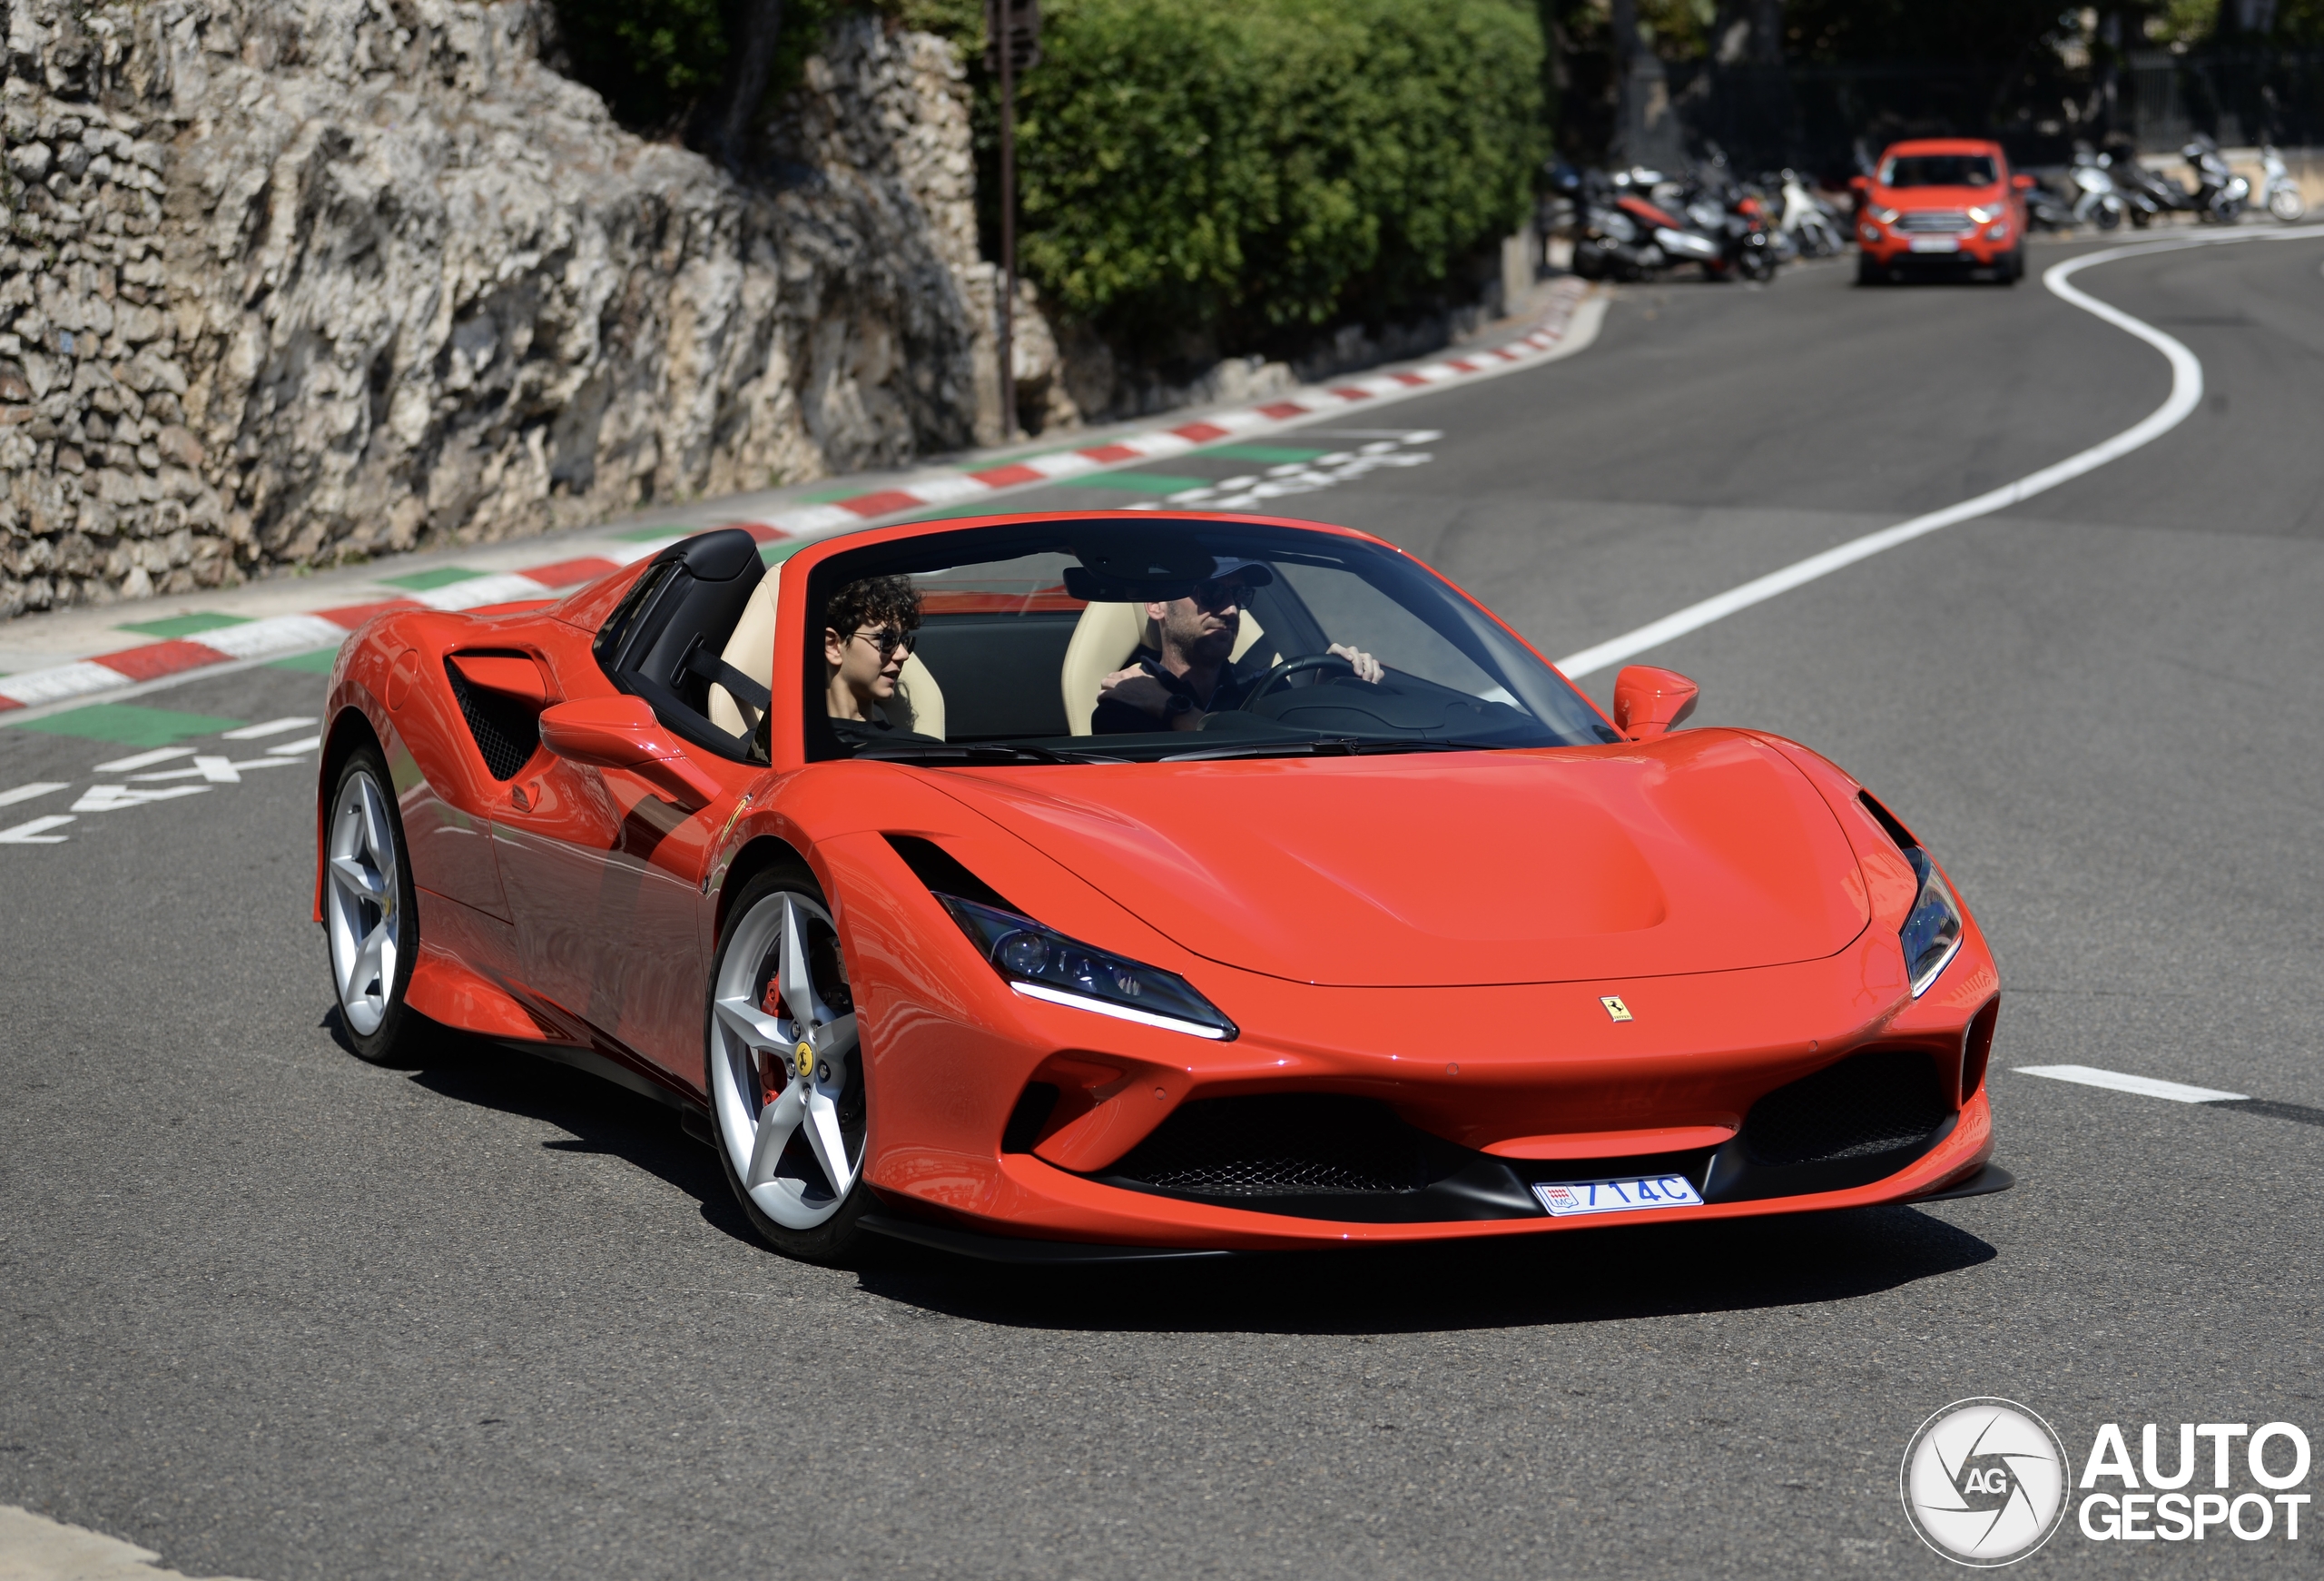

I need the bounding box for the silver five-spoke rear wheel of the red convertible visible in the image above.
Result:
[323,742,425,1065]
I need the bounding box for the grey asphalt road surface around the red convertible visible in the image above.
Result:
[0,242,2324,1581]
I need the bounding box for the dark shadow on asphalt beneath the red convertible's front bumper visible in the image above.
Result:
[860,1207,1999,1335]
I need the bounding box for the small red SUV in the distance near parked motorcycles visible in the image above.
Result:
[1850,137,2034,286]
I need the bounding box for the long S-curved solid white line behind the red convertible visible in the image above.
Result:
[1557,225,2324,679]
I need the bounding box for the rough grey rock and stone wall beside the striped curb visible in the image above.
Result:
[0,0,1036,614]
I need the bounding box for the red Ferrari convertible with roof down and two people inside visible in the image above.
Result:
[316,511,2008,1260]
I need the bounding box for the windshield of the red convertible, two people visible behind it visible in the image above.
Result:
[806,521,1620,763]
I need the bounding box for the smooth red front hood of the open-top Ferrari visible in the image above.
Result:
[932,730,1871,988]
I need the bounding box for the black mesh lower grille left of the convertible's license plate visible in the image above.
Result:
[1107,1095,1427,1198]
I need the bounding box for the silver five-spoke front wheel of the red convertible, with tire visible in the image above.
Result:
[704,863,874,1262]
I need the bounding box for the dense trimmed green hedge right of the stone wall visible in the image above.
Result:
[1018,0,1545,346]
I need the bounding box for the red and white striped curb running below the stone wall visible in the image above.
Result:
[0,279,1590,714]
